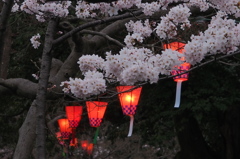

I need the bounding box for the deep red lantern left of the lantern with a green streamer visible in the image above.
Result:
[65,106,83,128]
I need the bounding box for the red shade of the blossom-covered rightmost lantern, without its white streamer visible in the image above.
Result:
[163,42,191,82]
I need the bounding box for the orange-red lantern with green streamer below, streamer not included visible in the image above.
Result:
[86,101,108,127]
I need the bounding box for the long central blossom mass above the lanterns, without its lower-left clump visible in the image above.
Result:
[75,47,183,88]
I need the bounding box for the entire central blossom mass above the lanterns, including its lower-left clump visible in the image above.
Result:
[61,48,184,98]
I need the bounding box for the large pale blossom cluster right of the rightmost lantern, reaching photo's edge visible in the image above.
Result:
[185,12,240,65]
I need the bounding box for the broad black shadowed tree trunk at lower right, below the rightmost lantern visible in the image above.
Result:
[174,111,216,159]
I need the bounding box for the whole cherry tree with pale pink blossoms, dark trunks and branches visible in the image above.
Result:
[0,0,240,159]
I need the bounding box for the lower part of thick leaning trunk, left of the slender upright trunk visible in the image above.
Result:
[13,100,36,159]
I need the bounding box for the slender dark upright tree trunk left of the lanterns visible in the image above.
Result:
[36,19,57,159]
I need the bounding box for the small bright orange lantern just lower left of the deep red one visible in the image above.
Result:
[58,119,72,139]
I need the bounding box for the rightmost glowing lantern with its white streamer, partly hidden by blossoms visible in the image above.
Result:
[163,42,191,108]
